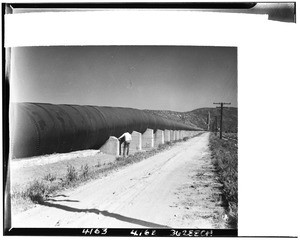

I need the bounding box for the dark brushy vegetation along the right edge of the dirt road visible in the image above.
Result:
[209,134,238,228]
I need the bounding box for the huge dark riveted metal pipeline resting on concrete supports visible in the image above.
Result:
[10,103,199,158]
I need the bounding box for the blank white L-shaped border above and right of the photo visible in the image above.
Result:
[5,3,300,236]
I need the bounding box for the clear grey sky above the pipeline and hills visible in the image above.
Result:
[11,46,237,112]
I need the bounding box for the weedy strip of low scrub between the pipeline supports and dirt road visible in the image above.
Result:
[11,133,202,213]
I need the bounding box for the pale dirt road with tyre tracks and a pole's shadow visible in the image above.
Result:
[12,133,225,228]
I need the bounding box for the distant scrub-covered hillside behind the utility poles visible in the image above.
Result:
[145,107,238,132]
